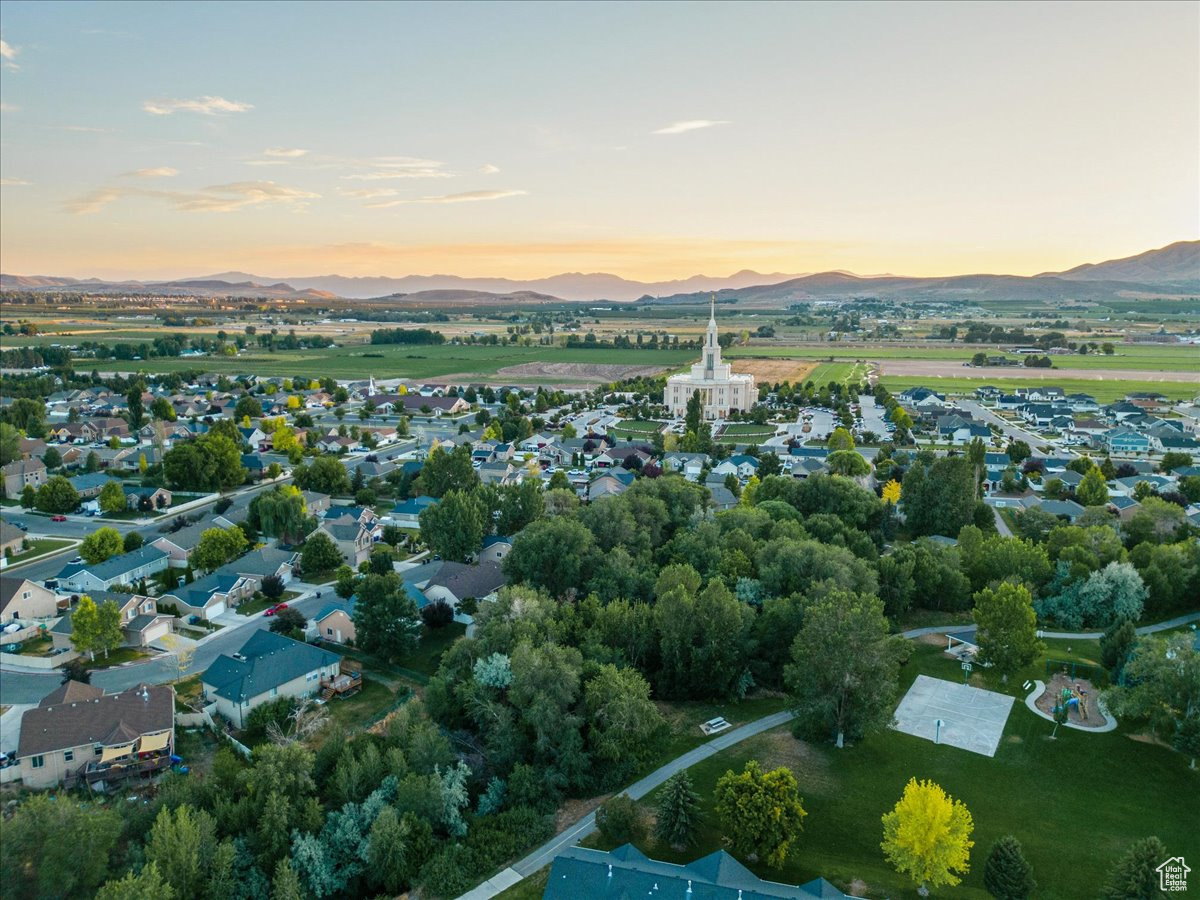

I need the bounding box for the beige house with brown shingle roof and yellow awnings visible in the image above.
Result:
[17,682,175,790]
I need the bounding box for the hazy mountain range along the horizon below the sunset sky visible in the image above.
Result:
[0,241,1200,307]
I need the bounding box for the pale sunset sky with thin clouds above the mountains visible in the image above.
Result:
[0,0,1200,280]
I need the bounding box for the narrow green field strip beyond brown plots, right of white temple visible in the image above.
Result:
[724,343,1200,372]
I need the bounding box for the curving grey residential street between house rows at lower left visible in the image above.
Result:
[0,583,334,706]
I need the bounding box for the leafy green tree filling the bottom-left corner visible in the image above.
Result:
[0,793,121,899]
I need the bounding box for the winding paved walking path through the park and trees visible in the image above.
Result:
[458,612,1200,900]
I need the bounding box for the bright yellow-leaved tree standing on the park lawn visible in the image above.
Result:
[880,778,974,896]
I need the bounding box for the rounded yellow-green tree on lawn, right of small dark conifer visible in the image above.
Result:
[713,760,808,869]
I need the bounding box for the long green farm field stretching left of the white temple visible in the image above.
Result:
[87,344,696,383]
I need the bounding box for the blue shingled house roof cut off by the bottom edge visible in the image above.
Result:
[542,844,848,900]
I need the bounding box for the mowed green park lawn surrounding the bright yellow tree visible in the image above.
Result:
[595,642,1200,898]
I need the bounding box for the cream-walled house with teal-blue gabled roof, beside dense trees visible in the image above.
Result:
[200,631,342,728]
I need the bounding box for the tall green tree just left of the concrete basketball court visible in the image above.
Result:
[784,590,901,748]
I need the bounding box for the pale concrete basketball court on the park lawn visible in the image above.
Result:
[892,676,1013,756]
